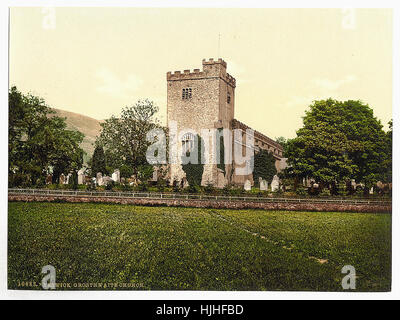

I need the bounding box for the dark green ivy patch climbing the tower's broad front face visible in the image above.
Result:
[182,135,204,186]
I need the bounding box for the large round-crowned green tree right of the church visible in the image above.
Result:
[286,99,387,188]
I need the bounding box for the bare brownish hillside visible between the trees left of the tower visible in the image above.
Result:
[53,108,103,162]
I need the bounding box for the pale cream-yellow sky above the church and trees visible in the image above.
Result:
[9,7,392,138]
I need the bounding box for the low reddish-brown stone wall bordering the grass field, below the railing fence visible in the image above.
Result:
[8,195,392,213]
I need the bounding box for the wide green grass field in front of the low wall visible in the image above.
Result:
[8,202,391,291]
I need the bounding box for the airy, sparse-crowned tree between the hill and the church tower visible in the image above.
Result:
[96,99,160,174]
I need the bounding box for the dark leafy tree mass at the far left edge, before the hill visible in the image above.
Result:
[8,86,84,186]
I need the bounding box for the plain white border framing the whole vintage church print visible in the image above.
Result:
[0,0,400,300]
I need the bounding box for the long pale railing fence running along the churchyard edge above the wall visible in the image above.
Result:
[8,189,392,205]
